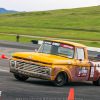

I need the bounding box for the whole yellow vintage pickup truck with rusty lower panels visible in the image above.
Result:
[9,40,100,86]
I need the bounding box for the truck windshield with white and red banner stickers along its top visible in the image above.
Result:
[38,41,75,58]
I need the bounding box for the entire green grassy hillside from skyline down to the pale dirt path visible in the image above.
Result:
[0,6,100,41]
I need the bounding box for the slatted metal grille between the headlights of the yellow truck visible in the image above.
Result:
[16,61,46,74]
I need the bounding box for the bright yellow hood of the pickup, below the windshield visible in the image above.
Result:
[13,52,72,64]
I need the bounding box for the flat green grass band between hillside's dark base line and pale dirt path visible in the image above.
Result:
[0,27,100,41]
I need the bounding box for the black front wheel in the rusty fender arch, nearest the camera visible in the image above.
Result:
[54,72,67,87]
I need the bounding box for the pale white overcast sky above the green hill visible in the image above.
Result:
[0,0,100,12]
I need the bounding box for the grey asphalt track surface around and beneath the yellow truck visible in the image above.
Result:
[0,40,100,100]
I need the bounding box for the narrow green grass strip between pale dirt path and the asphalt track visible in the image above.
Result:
[0,34,100,48]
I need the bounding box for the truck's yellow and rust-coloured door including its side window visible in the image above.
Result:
[74,47,89,81]
